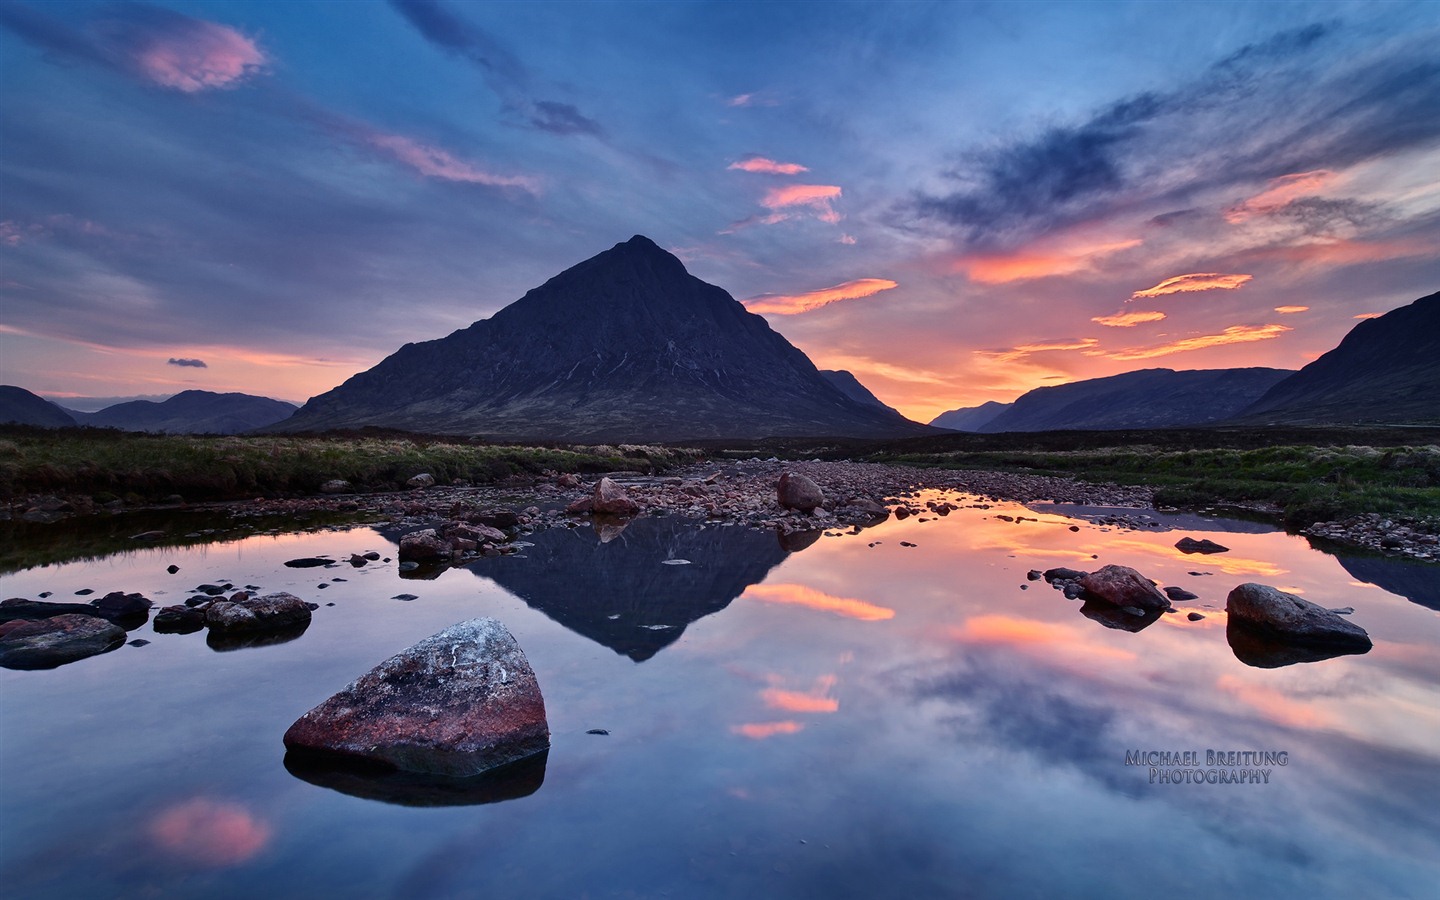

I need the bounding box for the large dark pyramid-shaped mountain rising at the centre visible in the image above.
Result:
[279,236,929,442]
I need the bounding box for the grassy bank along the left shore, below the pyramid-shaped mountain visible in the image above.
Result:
[0,428,693,503]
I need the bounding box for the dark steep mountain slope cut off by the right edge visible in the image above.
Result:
[1240,292,1440,425]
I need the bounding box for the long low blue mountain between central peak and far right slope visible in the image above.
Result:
[979,369,1293,433]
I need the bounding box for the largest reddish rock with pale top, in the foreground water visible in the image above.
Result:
[285,618,550,776]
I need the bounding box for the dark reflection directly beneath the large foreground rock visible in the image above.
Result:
[285,750,549,806]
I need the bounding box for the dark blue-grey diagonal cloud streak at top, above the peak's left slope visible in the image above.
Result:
[390,0,605,138]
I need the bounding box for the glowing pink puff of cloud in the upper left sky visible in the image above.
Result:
[122,14,269,94]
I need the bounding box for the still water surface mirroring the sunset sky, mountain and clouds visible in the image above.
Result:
[0,495,1440,900]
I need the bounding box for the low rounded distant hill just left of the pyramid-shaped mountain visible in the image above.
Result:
[73,390,295,435]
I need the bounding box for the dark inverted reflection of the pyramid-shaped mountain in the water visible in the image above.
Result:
[467,517,789,662]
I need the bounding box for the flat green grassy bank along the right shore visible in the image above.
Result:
[870,445,1440,527]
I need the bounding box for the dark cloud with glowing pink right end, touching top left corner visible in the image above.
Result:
[0,3,269,94]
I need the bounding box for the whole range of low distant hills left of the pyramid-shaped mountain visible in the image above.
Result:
[0,384,297,435]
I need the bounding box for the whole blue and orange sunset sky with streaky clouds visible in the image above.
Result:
[0,0,1440,420]
